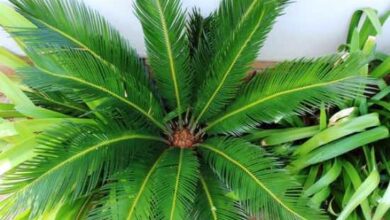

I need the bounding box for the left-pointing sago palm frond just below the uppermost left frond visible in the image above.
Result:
[19,50,165,130]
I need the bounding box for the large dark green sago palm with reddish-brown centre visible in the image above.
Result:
[0,0,372,220]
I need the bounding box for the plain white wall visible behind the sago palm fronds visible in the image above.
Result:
[0,0,390,60]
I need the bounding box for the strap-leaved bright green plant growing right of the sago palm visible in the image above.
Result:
[248,8,390,220]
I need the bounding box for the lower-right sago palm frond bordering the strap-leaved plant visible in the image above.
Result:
[199,138,325,219]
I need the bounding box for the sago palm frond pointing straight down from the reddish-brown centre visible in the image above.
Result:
[155,148,199,220]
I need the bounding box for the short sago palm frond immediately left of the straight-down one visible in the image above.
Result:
[89,151,165,220]
